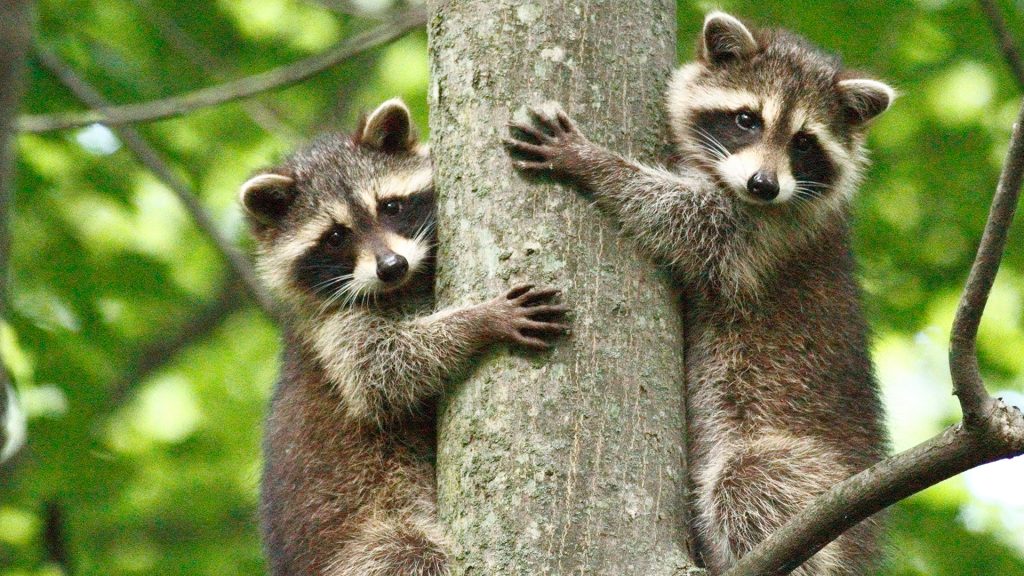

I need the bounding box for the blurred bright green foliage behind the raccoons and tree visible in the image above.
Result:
[0,0,1024,576]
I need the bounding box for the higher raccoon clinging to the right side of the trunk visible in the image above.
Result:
[507,12,895,576]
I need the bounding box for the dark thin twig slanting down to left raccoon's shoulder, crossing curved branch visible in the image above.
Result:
[36,48,275,318]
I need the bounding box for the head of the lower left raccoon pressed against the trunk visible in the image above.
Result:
[240,99,435,310]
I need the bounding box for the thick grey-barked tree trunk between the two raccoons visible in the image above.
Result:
[429,0,690,576]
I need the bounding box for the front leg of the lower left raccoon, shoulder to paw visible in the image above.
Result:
[312,286,568,423]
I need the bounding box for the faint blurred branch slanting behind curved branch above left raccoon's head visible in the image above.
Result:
[136,0,301,142]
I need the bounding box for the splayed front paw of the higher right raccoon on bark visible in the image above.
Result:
[503,104,590,176]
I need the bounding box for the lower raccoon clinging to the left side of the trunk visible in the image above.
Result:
[241,100,566,576]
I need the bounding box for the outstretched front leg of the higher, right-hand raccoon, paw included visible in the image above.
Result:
[505,107,734,271]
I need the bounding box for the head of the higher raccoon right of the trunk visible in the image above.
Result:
[668,12,896,205]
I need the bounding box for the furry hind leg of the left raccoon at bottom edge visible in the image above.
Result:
[325,517,449,576]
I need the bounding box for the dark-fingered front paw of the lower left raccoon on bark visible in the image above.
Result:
[483,285,569,349]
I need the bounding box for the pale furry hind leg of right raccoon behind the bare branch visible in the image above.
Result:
[695,435,877,576]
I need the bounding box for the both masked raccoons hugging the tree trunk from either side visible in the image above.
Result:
[242,8,895,576]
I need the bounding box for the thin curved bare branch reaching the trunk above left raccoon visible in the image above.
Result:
[18,7,427,132]
